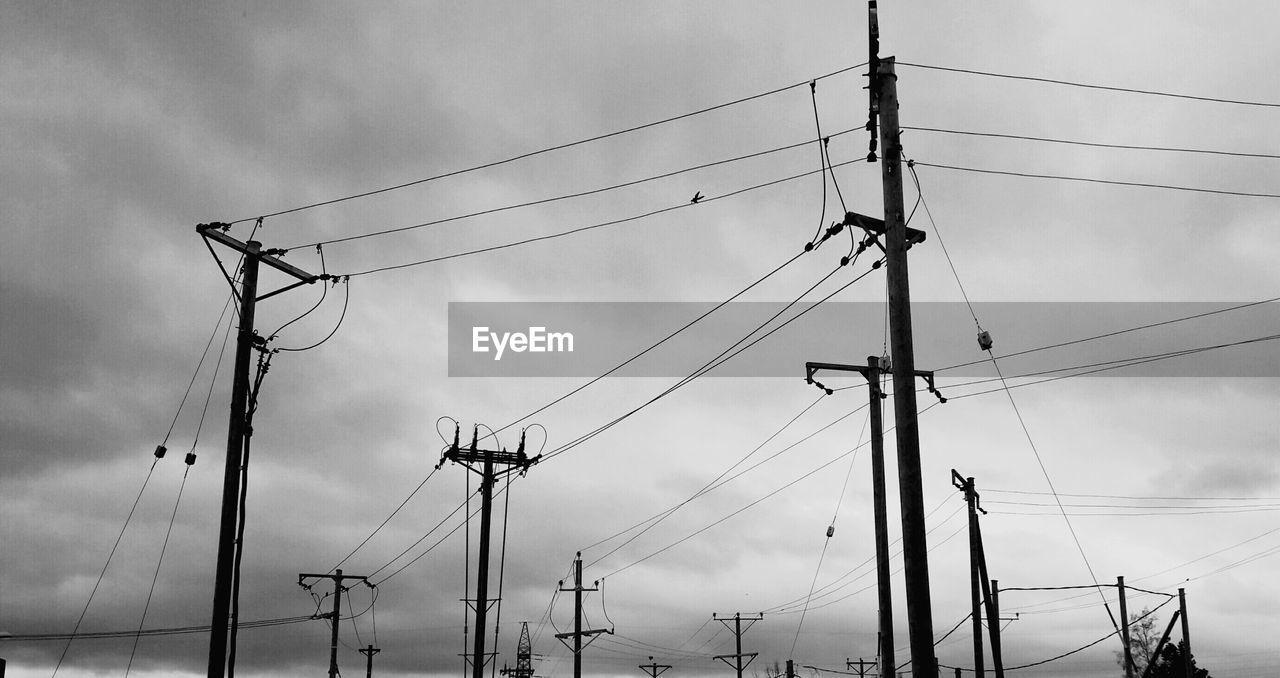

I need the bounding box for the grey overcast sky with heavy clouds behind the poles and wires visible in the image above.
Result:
[0,1,1280,678]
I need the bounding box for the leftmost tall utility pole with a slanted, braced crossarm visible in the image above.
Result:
[196,223,321,678]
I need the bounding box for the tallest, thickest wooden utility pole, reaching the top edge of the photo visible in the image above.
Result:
[868,0,937,660]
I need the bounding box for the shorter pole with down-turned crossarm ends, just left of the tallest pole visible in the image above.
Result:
[804,358,946,675]
